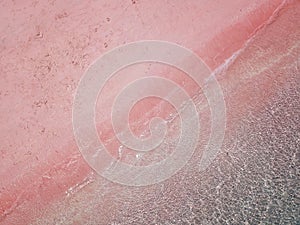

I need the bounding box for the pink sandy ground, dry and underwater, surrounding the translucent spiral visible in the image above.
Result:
[0,0,300,224]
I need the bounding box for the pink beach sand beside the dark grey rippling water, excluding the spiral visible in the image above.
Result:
[0,0,300,224]
